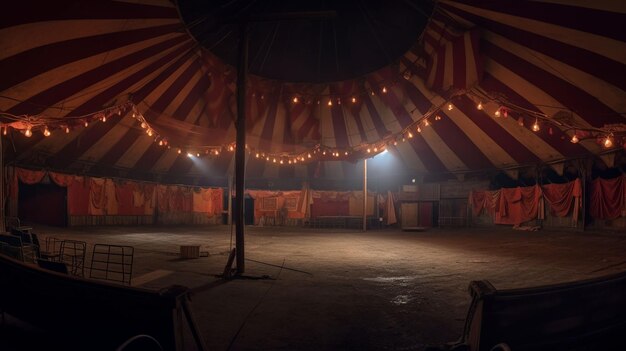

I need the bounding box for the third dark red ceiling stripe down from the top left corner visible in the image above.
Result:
[9,37,183,115]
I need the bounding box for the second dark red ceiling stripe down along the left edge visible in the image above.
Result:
[0,25,178,91]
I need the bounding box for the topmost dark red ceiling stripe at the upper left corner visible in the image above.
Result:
[0,0,178,30]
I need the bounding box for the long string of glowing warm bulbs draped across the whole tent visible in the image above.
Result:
[0,85,626,165]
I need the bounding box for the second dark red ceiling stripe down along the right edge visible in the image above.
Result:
[439,3,626,90]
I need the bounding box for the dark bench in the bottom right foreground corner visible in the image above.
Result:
[431,272,626,351]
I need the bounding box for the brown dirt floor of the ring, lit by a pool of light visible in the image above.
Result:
[1,226,626,350]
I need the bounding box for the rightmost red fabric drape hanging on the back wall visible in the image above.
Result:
[589,176,626,219]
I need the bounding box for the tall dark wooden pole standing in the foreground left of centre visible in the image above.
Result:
[235,20,248,275]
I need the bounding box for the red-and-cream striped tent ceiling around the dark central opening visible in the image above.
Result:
[0,0,626,186]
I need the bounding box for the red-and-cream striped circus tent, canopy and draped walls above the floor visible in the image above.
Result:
[0,0,626,348]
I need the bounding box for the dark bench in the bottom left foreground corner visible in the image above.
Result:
[0,255,205,350]
